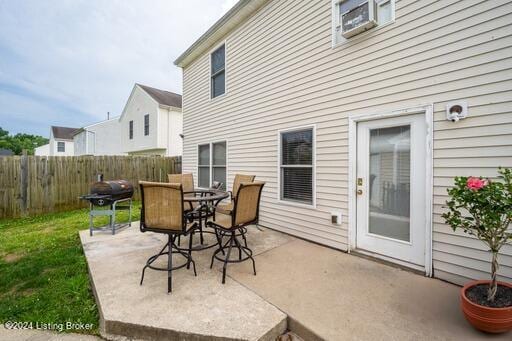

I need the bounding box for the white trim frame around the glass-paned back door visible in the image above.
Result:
[347,104,433,277]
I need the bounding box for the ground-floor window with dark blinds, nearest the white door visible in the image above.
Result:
[279,127,315,205]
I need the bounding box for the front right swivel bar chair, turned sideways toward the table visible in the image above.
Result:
[207,181,265,284]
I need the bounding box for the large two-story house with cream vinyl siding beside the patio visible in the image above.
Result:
[175,0,512,284]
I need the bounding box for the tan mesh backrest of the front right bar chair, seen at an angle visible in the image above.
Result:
[233,181,265,226]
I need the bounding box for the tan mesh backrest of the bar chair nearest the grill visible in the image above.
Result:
[139,181,185,231]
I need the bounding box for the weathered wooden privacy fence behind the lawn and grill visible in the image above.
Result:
[0,155,181,218]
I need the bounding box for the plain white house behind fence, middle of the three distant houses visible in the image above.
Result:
[73,117,126,156]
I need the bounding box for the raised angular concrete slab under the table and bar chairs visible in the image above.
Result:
[80,223,293,340]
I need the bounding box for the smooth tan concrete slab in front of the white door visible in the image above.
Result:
[230,240,512,341]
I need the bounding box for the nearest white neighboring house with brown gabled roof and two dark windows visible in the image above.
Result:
[119,84,183,156]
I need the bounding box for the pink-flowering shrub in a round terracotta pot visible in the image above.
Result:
[442,168,512,333]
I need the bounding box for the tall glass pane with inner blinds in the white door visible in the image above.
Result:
[368,125,411,241]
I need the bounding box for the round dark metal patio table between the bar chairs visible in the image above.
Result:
[183,189,229,251]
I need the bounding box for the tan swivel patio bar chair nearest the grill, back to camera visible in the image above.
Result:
[139,181,197,293]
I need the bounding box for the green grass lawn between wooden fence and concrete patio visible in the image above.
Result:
[0,203,140,334]
